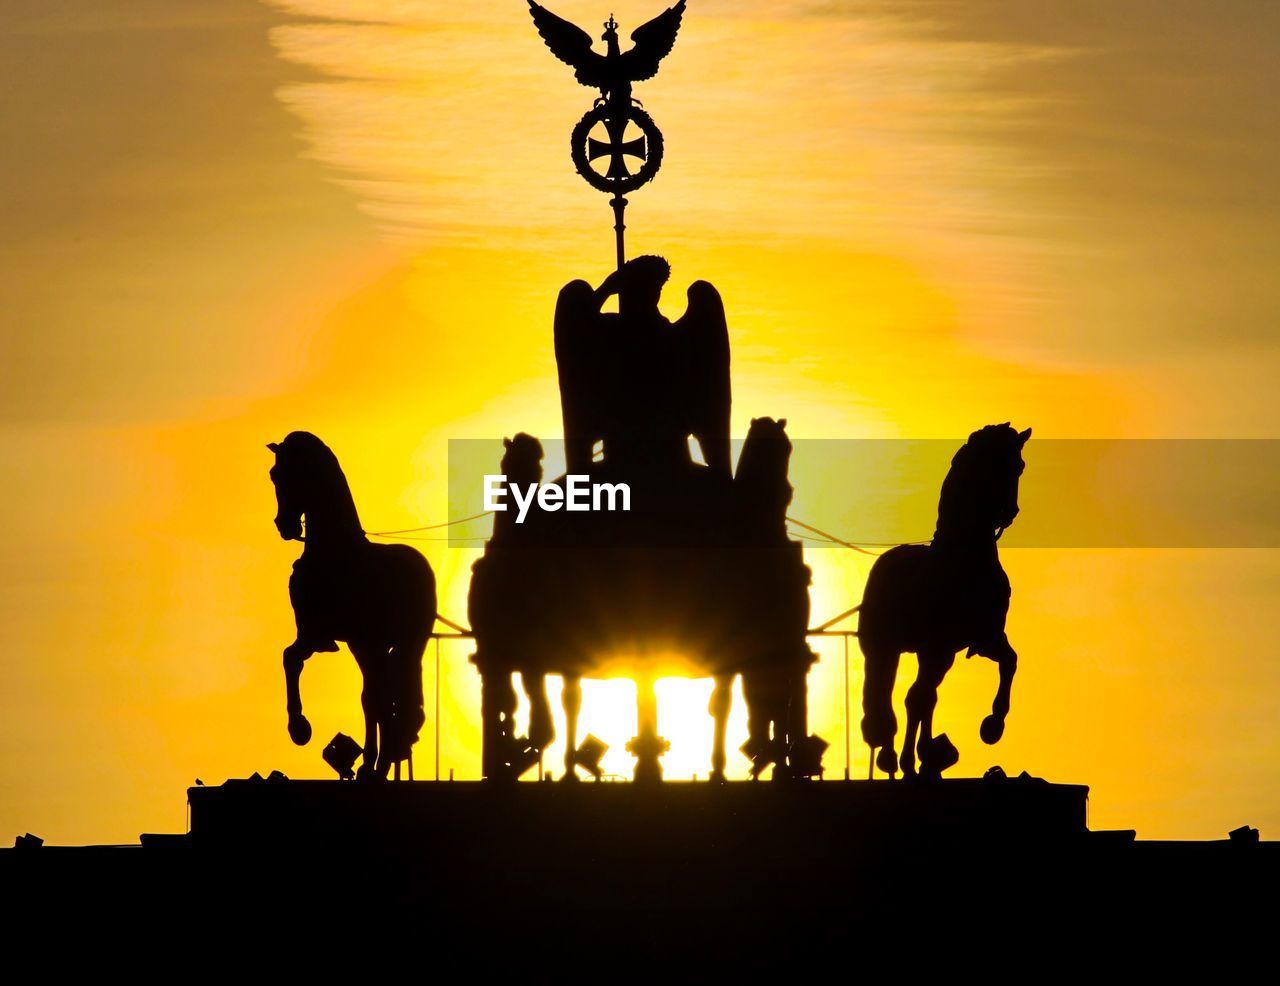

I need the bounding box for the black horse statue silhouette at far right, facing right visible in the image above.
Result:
[858,423,1032,777]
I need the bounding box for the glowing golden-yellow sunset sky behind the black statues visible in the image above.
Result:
[0,0,1280,843]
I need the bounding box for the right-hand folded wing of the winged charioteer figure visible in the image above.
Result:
[676,280,732,479]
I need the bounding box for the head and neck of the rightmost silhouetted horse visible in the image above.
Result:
[938,421,1032,539]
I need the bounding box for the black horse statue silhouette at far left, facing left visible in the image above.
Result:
[268,432,436,779]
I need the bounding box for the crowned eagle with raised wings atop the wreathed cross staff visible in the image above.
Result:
[529,0,685,105]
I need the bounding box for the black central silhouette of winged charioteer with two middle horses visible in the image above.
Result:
[468,256,820,780]
